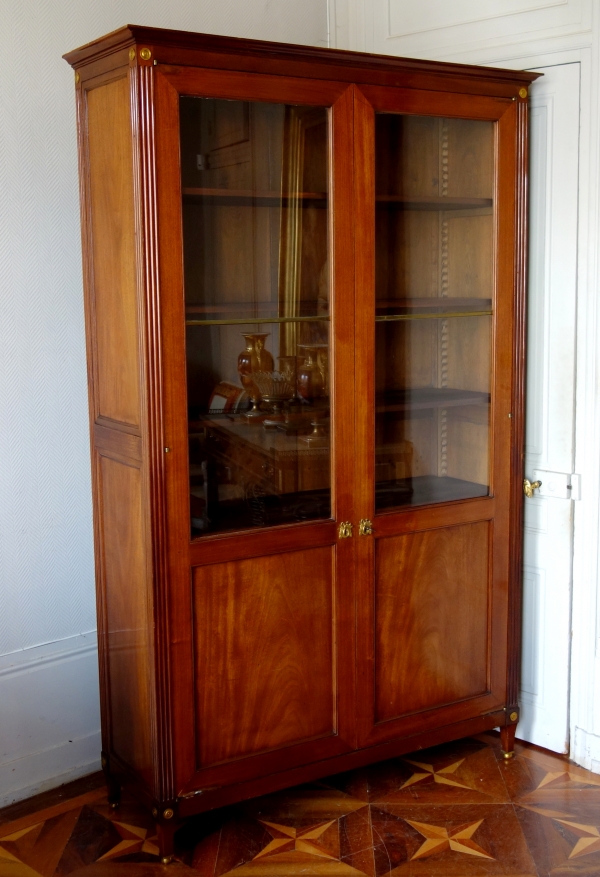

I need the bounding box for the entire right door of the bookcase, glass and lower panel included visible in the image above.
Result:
[355,88,520,745]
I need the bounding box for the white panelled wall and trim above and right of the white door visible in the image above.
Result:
[330,0,600,772]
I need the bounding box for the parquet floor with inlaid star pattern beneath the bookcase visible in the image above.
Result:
[0,734,600,877]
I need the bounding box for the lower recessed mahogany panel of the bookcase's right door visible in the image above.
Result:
[375,521,490,722]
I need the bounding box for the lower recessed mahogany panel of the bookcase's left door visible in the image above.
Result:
[193,547,337,768]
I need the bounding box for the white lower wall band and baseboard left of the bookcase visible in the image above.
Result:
[0,631,101,807]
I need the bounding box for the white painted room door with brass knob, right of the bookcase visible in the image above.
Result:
[517,64,579,752]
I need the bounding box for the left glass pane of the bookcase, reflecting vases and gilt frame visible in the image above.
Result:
[180,97,331,537]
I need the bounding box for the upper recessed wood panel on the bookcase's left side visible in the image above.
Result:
[87,78,140,426]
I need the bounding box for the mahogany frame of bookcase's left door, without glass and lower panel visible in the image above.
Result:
[154,65,355,797]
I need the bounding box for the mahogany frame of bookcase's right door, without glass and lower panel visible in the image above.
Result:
[355,86,527,746]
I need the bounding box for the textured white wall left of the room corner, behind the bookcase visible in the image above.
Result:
[0,0,328,806]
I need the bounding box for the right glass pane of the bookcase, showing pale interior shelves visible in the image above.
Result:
[375,114,494,510]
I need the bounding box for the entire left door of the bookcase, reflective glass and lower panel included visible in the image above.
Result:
[155,67,355,796]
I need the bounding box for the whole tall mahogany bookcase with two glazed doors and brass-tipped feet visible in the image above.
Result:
[65,25,538,861]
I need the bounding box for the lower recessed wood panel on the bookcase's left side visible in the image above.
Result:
[98,456,154,788]
